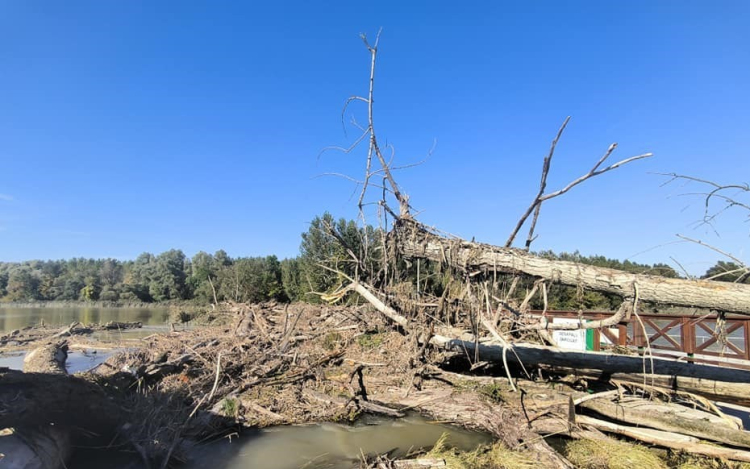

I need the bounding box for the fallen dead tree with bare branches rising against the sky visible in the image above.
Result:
[328,34,750,402]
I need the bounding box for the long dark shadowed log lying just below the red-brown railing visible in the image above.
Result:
[430,335,750,383]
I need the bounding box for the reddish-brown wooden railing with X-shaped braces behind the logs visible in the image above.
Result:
[531,311,750,369]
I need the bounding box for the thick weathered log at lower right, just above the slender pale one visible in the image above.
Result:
[576,399,750,448]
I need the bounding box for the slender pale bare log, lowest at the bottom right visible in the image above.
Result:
[576,415,750,462]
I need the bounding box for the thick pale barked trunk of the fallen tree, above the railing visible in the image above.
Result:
[400,219,750,315]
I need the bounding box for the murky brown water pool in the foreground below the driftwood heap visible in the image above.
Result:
[68,414,492,469]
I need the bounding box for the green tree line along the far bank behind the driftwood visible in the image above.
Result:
[0,212,750,310]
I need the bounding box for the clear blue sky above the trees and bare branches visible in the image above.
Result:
[0,1,750,273]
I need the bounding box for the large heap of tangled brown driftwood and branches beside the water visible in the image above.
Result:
[0,303,741,469]
